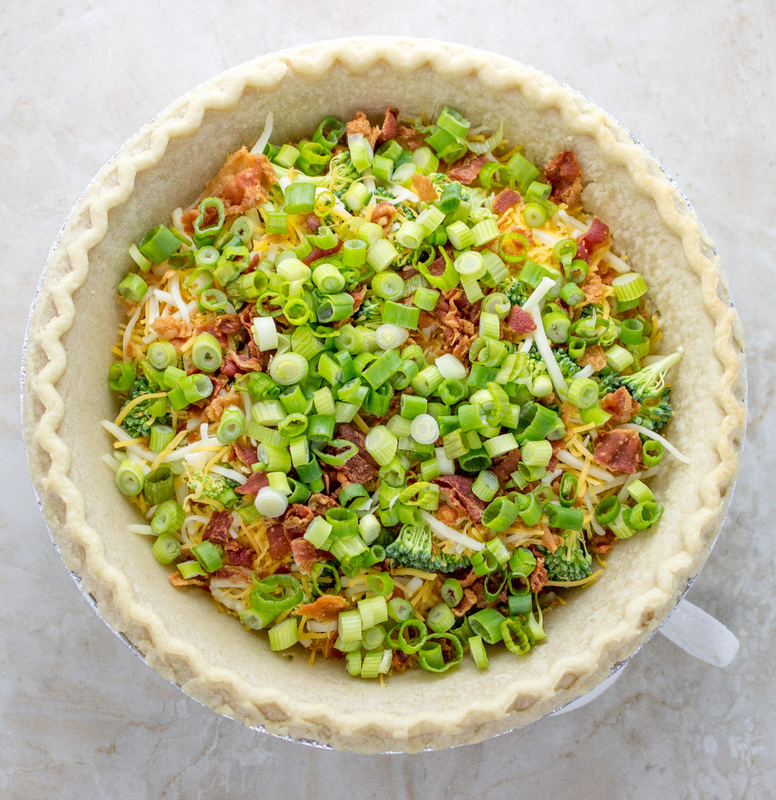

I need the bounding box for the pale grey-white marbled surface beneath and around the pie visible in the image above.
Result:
[0,0,776,800]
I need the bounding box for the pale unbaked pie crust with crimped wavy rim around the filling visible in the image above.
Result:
[24,38,745,752]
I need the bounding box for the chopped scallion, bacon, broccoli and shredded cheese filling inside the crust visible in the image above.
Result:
[103,107,686,678]
